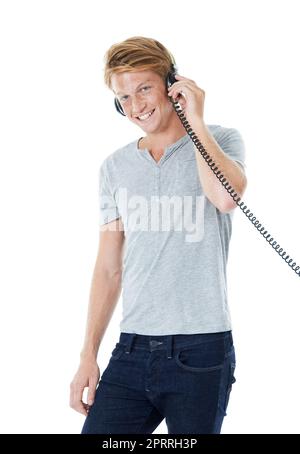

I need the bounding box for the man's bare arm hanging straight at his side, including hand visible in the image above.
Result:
[70,218,124,415]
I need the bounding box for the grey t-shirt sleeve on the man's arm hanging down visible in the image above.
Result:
[98,160,120,226]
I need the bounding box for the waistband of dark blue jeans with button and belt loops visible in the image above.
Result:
[119,331,233,358]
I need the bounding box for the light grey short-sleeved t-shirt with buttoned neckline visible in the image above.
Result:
[99,125,245,335]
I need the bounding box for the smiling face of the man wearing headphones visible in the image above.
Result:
[111,70,175,133]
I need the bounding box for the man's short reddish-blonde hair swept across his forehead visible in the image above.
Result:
[104,36,176,89]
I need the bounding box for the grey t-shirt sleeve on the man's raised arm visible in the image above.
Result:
[218,128,246,170]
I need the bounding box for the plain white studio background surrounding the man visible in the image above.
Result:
[0,0,300,434]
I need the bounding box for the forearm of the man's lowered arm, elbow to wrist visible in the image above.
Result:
[80,268,122,359]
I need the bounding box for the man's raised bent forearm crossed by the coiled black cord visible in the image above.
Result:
[194,121,247,211]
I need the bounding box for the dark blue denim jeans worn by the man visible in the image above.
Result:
[81,331,235,434]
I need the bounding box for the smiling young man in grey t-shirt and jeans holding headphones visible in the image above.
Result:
[70,36,247,434]
